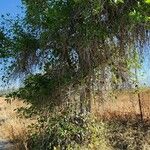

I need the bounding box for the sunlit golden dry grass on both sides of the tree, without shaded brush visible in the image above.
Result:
[0,89,150,150]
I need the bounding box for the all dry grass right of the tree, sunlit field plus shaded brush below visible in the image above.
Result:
[90,89,150,150]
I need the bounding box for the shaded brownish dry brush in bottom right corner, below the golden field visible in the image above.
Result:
[105,115,150,150]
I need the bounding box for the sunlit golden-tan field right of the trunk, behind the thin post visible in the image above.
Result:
[93,89,150,119]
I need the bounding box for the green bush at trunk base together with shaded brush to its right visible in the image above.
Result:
[25,109,150,150]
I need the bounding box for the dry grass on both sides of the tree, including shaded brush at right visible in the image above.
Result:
[0,89,150,150]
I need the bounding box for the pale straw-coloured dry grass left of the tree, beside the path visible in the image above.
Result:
[0,98,33,150]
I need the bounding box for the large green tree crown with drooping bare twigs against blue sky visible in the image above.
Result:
[1,0,150,111]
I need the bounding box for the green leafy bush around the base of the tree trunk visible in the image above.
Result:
[28,113,108,150]
